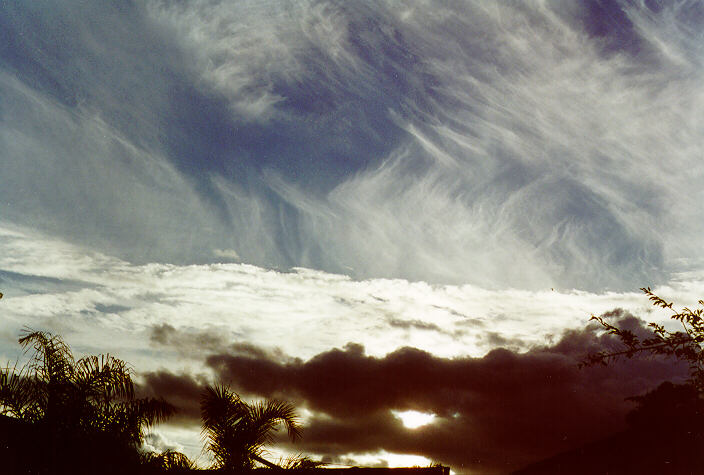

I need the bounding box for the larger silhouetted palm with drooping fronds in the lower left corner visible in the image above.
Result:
[0,330,175,474]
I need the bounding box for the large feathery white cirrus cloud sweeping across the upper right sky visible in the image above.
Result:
[278,0,701,288]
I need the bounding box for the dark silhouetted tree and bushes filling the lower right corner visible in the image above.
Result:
[568,287,704,473]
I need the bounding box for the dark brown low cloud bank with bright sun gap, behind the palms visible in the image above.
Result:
[146,310,686,473]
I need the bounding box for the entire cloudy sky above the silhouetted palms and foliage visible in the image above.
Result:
[0,0,704,474]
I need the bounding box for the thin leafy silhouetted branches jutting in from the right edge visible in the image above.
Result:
[582,287,704,394]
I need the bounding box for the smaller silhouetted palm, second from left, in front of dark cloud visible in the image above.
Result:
[200,385,301,470]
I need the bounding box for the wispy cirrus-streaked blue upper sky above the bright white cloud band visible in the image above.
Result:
[5,0,704,291]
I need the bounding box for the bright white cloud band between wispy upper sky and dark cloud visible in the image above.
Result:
[0,227,704,371]
